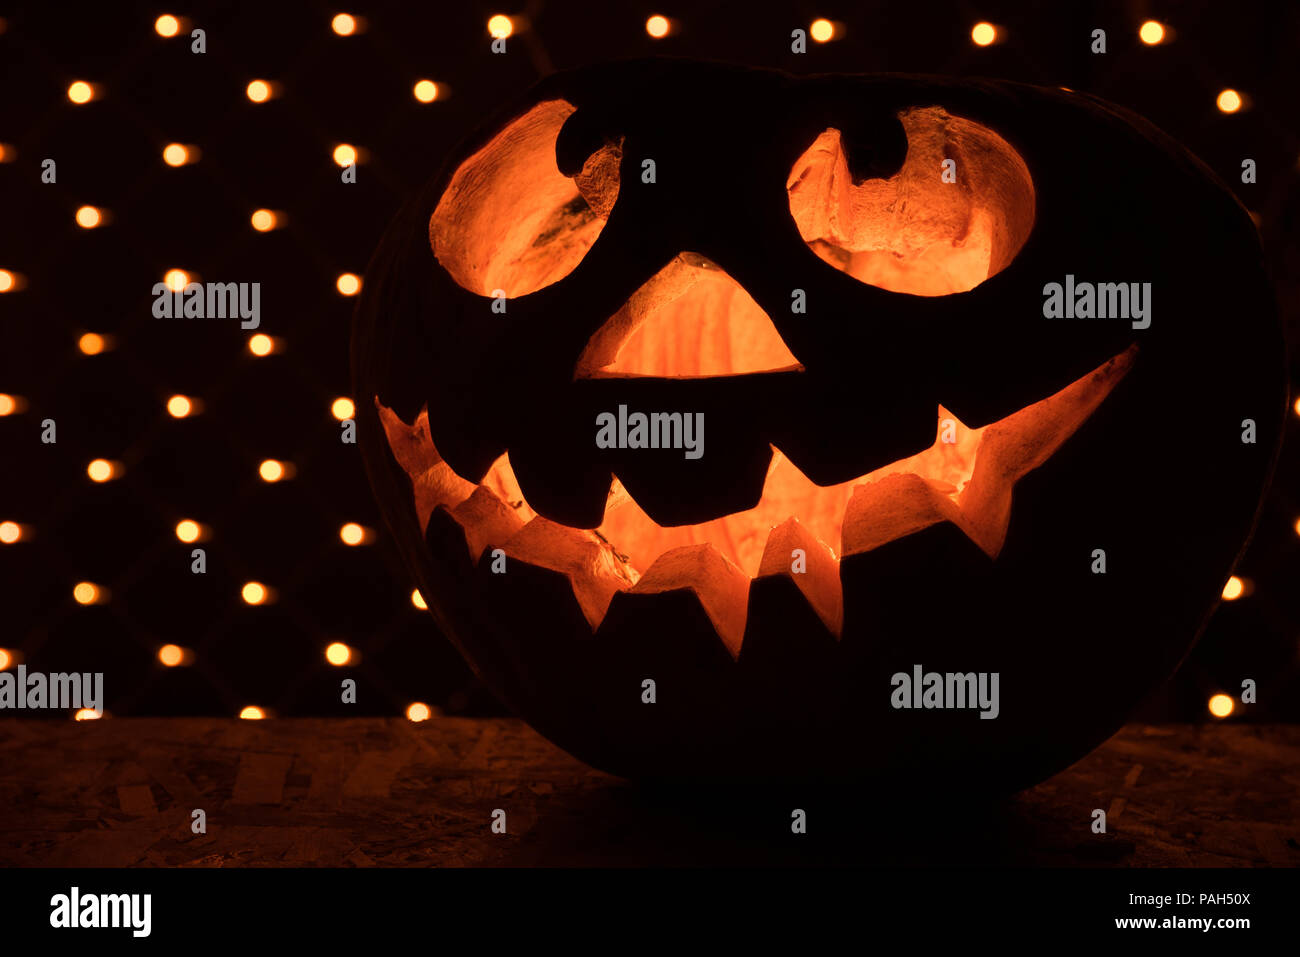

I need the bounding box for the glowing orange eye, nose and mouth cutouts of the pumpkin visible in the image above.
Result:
[410,100,1136,654]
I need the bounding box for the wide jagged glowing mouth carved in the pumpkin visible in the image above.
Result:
[374,346,1138,655]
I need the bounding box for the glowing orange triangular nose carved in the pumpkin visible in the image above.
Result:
[573,251,803,378]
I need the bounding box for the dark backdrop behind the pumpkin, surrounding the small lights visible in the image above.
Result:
[0,0,1300,720]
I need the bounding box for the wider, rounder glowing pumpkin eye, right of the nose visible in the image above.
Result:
[785,107,1034,295]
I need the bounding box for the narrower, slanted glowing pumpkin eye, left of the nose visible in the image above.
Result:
[429,100,623,299]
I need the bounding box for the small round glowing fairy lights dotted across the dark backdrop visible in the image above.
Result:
[0,13,1279,722]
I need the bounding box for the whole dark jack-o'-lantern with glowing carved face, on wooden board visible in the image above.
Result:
[352,61,1284,789]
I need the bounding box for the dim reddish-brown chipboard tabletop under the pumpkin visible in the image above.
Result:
[0,718,1300,867]
